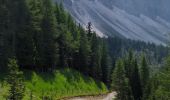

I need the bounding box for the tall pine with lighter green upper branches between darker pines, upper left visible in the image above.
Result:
[28,0,44,69]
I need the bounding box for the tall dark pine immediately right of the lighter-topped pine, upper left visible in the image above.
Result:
[41,0,58,69]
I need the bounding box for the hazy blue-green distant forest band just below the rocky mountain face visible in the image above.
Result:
[105,37,169,66]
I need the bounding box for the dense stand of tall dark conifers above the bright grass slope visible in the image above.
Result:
[0,0,109,88]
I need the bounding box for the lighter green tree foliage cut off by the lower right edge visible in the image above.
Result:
[148,57,170,100]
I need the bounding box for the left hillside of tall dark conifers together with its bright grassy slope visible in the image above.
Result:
[0,0,111,100]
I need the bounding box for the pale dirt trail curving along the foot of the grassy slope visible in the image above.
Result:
[65,92,116,100]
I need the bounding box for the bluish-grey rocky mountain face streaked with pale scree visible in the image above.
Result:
[56,0,170,45]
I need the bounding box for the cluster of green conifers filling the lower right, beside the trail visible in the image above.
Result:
[112,51,170,100]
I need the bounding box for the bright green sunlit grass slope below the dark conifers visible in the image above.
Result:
[0,69,108,100]
